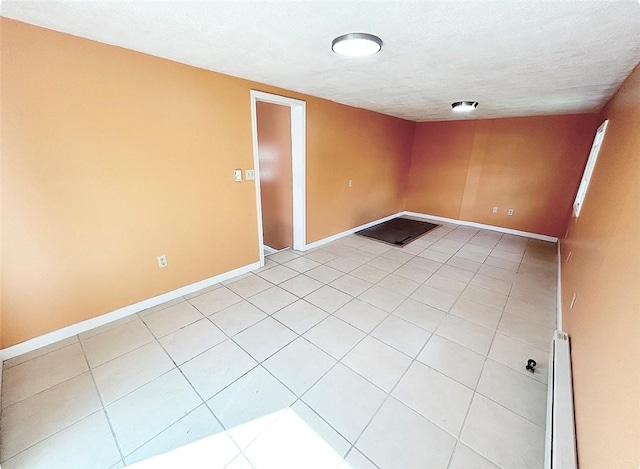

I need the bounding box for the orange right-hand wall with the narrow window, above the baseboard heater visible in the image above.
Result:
[561,65,640,469]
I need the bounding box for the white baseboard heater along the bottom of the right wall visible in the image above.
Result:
[544,331,578,469]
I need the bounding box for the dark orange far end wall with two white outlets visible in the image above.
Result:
[407,114,596,236]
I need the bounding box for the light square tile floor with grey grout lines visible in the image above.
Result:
[1,220,556,469]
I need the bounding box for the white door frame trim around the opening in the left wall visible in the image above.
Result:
[251,90,307,265]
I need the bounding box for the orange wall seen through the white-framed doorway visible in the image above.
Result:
[256,101,293,249]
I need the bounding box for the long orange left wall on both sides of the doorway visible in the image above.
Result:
[0,18,414,347]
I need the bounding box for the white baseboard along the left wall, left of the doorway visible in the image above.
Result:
[0,262,260,360]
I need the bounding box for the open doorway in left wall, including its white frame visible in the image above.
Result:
[251,90,306,265]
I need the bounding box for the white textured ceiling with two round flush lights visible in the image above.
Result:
[1,0,640,121]
